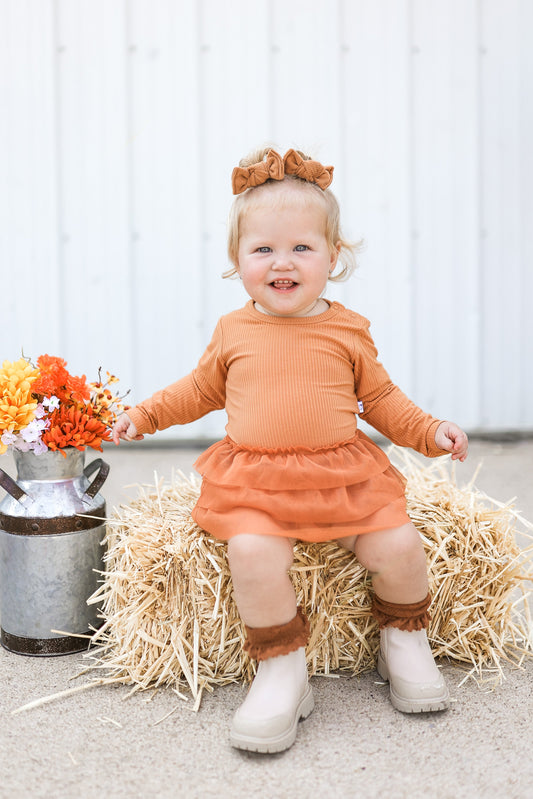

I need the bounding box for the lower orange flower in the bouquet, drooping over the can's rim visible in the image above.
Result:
[43,405,111,454]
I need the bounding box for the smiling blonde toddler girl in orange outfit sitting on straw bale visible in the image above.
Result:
[113,145,468,752]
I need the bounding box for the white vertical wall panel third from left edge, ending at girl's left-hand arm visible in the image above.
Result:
[127,0,205,436]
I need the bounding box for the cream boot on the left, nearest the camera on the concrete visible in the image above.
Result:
[230,646,314,752]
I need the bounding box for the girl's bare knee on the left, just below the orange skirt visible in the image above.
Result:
[228,534,294,581]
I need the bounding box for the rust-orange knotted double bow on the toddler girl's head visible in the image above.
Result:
[231,150,333,194]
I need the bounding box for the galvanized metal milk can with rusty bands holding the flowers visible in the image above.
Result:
[0,447,109,655]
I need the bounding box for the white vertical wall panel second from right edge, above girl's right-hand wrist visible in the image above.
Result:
[413,0,479,427]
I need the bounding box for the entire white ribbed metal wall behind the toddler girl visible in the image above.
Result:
[0,0,533,438]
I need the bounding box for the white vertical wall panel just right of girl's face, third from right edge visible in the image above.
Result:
[339,0,412,393]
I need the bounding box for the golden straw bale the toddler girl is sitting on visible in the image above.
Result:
[85,449,532,706]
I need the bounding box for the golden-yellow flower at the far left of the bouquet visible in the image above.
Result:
[0,358,39,454]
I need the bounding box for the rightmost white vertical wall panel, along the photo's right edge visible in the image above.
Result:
[481,0,533,429]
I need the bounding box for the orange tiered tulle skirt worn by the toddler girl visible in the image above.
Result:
[192,431,409,542]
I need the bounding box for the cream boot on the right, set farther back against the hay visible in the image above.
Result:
[377,627,450,713]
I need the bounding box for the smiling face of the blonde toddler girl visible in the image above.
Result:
[237,198,338,316]
